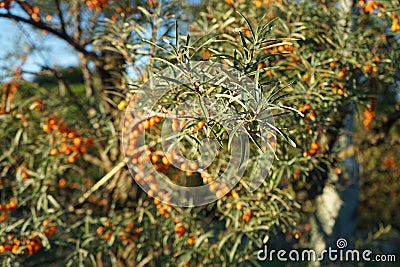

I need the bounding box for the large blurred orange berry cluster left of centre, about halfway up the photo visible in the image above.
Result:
[43,116,94,163]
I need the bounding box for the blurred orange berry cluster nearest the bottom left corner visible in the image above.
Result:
[0,219,57,255]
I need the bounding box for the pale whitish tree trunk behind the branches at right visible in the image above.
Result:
[311,0,359,265]
